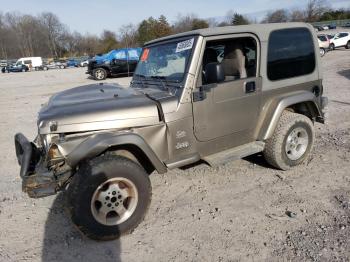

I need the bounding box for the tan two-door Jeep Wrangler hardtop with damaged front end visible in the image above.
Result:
[15,23,327,240]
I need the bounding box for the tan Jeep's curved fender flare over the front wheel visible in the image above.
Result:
[66,133,167,174]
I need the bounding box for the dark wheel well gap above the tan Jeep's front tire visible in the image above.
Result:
[102,144,155,174]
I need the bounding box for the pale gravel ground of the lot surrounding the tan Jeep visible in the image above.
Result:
[0,49,350,261]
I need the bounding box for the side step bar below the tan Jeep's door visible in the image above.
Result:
[203,141,265,166]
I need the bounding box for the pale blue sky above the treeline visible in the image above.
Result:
[0,0,350,34]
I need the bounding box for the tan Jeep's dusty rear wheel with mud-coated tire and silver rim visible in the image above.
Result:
[263,111,315,170]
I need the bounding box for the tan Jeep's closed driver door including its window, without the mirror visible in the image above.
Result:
[193,34,261,142]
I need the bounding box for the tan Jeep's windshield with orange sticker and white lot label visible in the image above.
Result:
[135,37,194,82]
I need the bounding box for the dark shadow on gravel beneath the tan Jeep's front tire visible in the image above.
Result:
[42,193,121,262]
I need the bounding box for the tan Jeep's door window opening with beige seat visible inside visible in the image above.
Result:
[202,37,257,84]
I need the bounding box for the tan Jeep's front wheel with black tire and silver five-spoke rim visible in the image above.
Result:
[66,155,152,240]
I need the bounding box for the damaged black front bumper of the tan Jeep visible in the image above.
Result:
[15,133,71,198]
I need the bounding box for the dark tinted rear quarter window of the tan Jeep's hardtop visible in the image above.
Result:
[267,28,316,81]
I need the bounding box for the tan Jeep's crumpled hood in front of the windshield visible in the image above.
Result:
[38,84,177,134]
